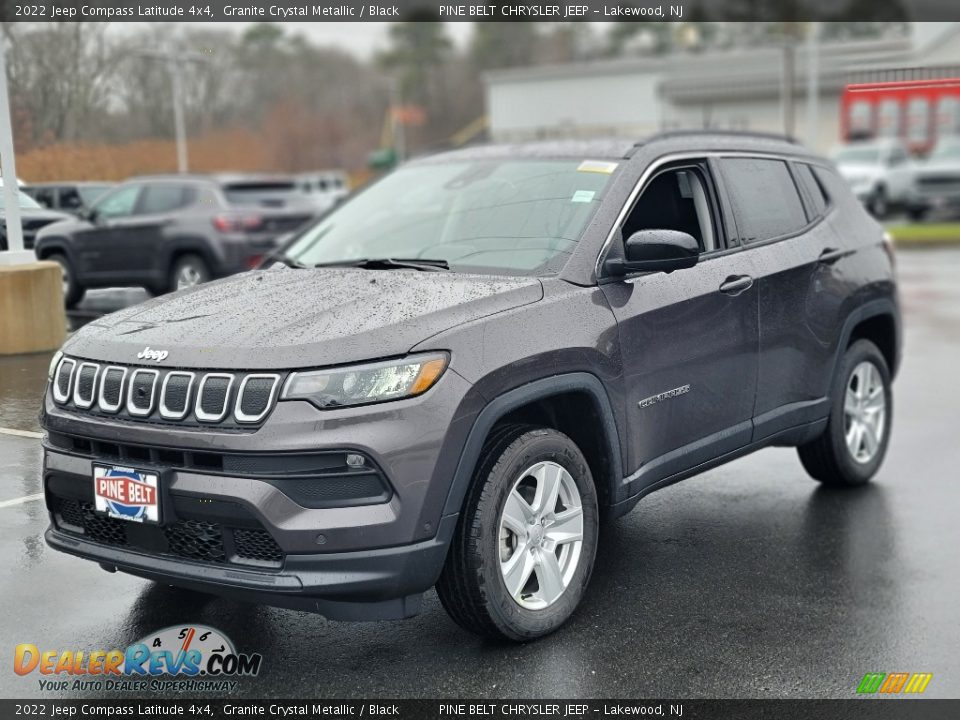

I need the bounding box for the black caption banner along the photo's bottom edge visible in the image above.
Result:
[0,698,960,720]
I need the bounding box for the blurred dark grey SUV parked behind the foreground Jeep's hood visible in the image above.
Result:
[36,175,314,306]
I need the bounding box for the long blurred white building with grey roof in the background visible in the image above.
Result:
[486,23,960,150]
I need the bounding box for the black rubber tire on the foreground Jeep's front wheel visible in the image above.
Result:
[437,425,599,642]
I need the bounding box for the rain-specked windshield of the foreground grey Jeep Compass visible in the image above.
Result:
[286,160,615,274]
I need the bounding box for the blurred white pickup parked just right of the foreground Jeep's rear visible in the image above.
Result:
[832,139,916,218]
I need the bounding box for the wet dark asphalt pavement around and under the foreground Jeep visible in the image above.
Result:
[0,250,960,698]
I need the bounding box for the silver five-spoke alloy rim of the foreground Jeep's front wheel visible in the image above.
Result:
[499,461,583,610]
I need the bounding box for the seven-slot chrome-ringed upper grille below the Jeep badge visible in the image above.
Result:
[51,357,283,427]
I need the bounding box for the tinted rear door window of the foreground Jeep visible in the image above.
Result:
[722,158,807,242]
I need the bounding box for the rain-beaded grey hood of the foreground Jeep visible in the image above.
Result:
[64,268,543,370]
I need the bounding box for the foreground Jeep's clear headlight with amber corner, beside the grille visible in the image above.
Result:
[280,354,447,408]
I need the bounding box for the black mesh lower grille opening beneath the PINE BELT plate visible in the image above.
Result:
[53,497,284,568]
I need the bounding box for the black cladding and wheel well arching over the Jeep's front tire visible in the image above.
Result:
[443,372,623,515]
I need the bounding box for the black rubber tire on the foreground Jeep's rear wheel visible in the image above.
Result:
[797,340,893,487]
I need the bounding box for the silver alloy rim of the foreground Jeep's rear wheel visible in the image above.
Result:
[843,360,887,463]
